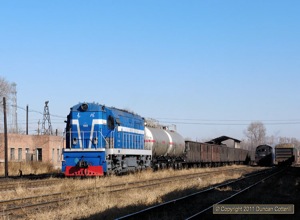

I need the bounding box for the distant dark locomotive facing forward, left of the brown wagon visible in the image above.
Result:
[255,144,274,166]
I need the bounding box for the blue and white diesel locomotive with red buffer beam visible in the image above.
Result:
[62,103,151,176]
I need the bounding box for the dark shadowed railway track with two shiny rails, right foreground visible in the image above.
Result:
[118,168,283,219]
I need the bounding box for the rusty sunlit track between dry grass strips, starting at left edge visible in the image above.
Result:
[0,168,262,216]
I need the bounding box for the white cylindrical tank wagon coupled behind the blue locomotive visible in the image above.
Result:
[145,121,185,168]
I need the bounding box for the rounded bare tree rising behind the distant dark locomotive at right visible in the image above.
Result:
[244,121,266,149]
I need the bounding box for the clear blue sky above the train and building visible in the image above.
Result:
[0,0,300,140]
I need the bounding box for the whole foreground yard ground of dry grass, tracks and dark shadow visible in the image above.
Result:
[0,165,300,220]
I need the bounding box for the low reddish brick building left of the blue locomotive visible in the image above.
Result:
[0,133,64,168]
